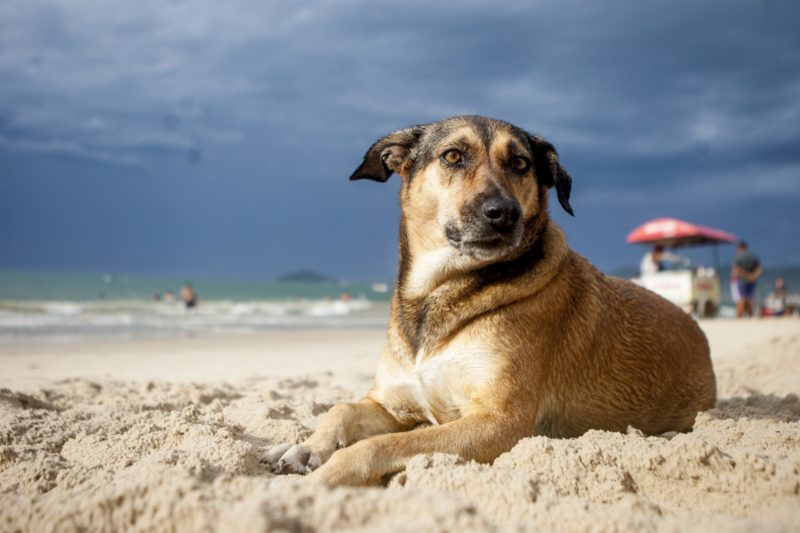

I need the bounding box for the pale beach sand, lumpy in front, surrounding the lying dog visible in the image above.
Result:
[0,319,800,531]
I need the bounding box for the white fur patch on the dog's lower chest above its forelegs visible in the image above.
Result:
[376,337,497,424]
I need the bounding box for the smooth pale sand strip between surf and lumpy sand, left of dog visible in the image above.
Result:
[0,328,386,391]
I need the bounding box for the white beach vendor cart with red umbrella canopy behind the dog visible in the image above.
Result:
[626,218,736,317]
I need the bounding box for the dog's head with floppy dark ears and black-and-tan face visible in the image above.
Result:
[350,116,572,261]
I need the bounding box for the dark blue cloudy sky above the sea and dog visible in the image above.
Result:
[0,0,800,281]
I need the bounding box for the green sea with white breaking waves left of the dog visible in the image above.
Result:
[0,272,391,344]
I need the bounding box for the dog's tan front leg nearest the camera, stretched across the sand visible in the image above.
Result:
[310,414,533,485]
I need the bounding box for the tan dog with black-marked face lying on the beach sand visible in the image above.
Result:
[266,116,716,485]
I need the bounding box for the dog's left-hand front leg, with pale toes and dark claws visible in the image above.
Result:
[266,398,412,474]
